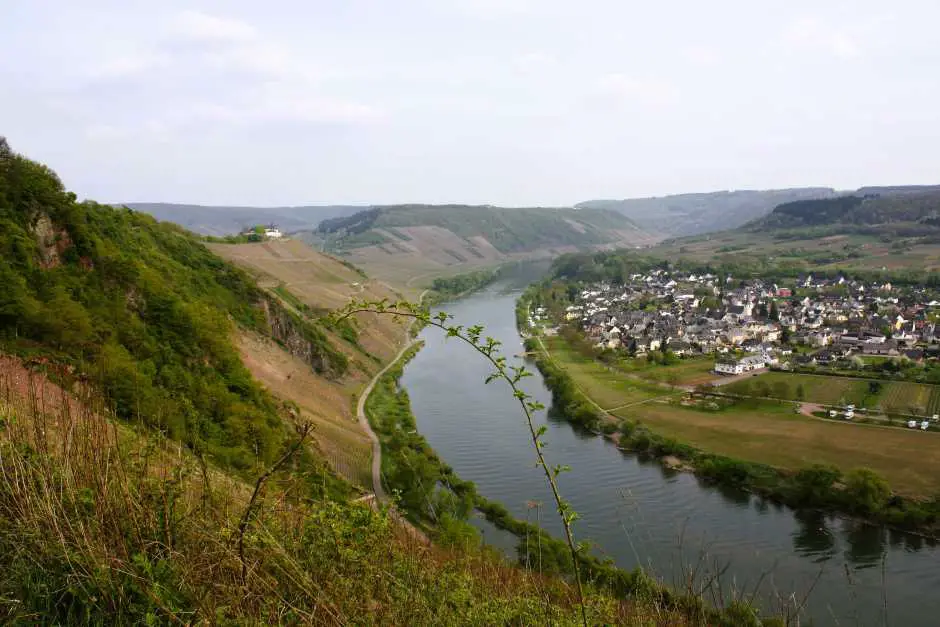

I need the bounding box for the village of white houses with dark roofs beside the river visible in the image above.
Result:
[565,270,940,374]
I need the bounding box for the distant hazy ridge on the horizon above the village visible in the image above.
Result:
[577,187,836,237]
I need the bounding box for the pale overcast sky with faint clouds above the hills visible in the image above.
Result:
[0,0,940,206]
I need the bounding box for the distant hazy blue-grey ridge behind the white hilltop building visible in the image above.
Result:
[117,202,362,236]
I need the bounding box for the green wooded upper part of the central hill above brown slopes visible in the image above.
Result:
[317,205,648,253]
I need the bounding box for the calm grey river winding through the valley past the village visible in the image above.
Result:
[402,285,940,626]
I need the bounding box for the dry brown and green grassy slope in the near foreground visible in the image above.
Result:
[0,356,693,625]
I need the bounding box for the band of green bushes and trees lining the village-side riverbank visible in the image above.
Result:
[517,252,940,535]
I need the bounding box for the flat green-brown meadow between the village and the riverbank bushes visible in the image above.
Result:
[548,338,940,497]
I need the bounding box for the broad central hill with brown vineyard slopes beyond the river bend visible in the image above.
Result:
[301,205,655,283]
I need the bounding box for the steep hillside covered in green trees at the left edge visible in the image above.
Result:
[0,139,347,469]
